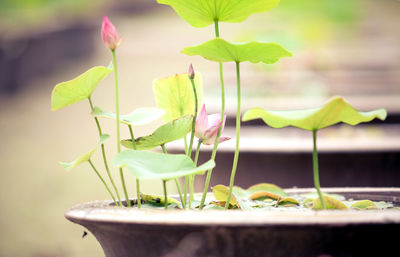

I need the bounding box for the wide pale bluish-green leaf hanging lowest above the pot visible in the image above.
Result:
[112,150,215,180]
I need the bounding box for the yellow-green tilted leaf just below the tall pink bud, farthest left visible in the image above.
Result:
[51,66,112,111]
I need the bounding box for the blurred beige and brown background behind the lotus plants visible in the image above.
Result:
[0,0,400,257]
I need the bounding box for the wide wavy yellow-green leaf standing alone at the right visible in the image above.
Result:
[243,97,387,131]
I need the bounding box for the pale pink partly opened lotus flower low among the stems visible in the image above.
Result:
[194,104,230,145]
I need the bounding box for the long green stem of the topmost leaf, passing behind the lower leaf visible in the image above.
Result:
[199,20,225,210]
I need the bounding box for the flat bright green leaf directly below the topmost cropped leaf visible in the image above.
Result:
[182,38,292,64]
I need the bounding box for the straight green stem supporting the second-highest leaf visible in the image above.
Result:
[225,62,241,209]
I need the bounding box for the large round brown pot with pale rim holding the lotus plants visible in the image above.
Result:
[65,188,400,257]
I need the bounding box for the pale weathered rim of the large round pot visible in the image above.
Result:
[65,188,400,226]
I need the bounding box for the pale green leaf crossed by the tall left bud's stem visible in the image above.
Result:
[92,107,165,126]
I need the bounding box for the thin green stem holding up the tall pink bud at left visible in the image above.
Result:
[111,50,132,207]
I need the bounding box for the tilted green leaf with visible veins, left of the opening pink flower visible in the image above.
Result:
[121,115,193,150]
